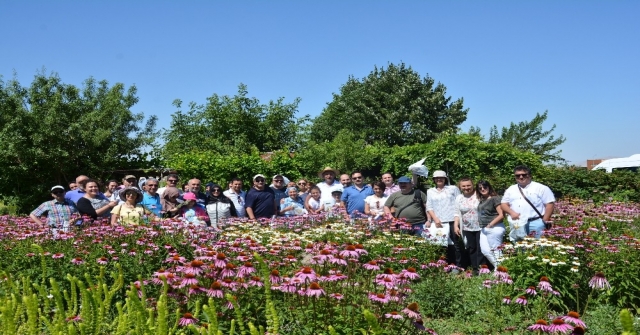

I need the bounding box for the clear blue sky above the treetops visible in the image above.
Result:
[0,0,640,165]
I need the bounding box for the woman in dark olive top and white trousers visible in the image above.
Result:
[477,180,505,267]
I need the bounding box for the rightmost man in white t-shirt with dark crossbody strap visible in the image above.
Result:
[500,165,556,238]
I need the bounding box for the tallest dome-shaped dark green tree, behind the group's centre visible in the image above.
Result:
[311,63,468,146]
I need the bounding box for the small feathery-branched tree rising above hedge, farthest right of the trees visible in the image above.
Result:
[489,111,567,163]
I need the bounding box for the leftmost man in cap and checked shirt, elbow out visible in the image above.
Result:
[29,185,78,229]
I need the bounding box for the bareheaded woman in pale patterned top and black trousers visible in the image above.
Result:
[454,177,480,275]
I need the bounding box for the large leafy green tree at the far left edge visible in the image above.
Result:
[0,74,158,210]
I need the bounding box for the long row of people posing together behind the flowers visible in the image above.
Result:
[30,166,555,272]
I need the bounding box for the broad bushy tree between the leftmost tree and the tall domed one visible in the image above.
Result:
[164,84,308,158]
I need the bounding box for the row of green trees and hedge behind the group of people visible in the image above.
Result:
[0,63,565,212]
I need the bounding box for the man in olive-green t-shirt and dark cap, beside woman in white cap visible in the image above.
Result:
[384,176,427,235]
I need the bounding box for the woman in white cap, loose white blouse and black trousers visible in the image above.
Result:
[427,170,462,267]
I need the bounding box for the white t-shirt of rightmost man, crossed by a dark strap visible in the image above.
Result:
[501,181,556,218]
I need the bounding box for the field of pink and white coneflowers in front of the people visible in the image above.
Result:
[0,201,640,334]
